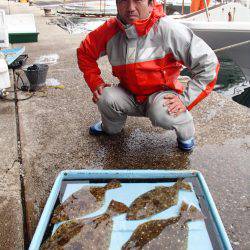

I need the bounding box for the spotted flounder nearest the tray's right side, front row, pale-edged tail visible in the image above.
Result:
[122,202,204,250]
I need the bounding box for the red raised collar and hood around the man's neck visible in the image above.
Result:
[116,0,166,38]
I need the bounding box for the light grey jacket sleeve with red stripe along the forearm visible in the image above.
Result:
[165,19,220,110]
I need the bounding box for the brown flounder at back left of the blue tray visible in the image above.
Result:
[51,180,121,224]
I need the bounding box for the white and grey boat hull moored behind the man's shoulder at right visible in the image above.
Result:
[177,3,250,81]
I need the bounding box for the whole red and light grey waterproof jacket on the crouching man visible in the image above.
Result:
[77,6,219,110]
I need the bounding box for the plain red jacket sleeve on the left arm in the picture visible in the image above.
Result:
[77,19,116,92]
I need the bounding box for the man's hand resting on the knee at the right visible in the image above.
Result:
[164,94,187,116]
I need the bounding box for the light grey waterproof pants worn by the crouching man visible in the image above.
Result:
[97,86,195,140]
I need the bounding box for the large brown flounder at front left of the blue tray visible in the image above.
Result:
[41,200,128,250]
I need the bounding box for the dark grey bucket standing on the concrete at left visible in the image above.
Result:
[24,64,49,91]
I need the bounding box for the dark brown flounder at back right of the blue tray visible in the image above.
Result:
[126,180,192,220]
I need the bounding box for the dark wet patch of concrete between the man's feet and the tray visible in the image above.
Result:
[93,128,189,169]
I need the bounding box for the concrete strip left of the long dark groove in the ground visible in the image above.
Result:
[0,87,23,249]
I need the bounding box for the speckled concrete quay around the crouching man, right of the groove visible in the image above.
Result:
[0,0,250,249]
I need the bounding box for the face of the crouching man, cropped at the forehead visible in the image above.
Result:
[116,0,153,24]
